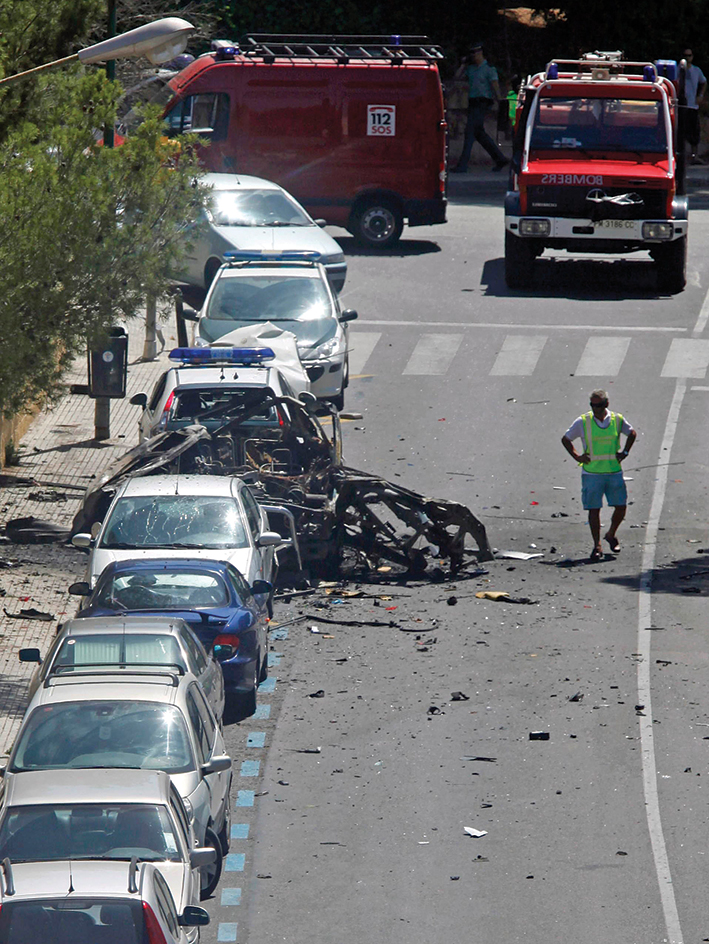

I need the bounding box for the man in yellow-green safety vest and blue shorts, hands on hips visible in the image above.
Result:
[561,390,638,560]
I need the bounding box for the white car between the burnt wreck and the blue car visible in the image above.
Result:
[72,475,284,589]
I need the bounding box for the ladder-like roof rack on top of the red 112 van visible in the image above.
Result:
[239,33,443,64]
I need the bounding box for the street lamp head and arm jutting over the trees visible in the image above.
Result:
[0,16,194,85]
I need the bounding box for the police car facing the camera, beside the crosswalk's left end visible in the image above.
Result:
[186,251,357,410]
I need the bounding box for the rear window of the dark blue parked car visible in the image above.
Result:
[93,570,229,612]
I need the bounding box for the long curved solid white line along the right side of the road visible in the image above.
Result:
[636,380,687,944]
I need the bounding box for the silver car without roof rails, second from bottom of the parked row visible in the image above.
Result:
[0,770,215,941]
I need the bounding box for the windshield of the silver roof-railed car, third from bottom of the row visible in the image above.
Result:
[11,696,194,773]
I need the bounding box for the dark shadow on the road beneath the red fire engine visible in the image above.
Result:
[480,257,659,301]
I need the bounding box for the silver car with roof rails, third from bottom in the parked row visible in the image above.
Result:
[5,667,231,897]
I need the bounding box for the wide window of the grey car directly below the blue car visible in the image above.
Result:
[52,636,184,675]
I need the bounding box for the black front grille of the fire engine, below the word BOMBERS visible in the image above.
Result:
[527,185,667,220]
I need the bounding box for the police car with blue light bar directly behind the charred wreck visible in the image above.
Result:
[130,347,309,442]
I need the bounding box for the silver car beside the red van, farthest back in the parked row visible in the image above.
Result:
[177,174,347,292]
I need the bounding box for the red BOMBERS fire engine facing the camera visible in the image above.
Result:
[505,52,688,293]
